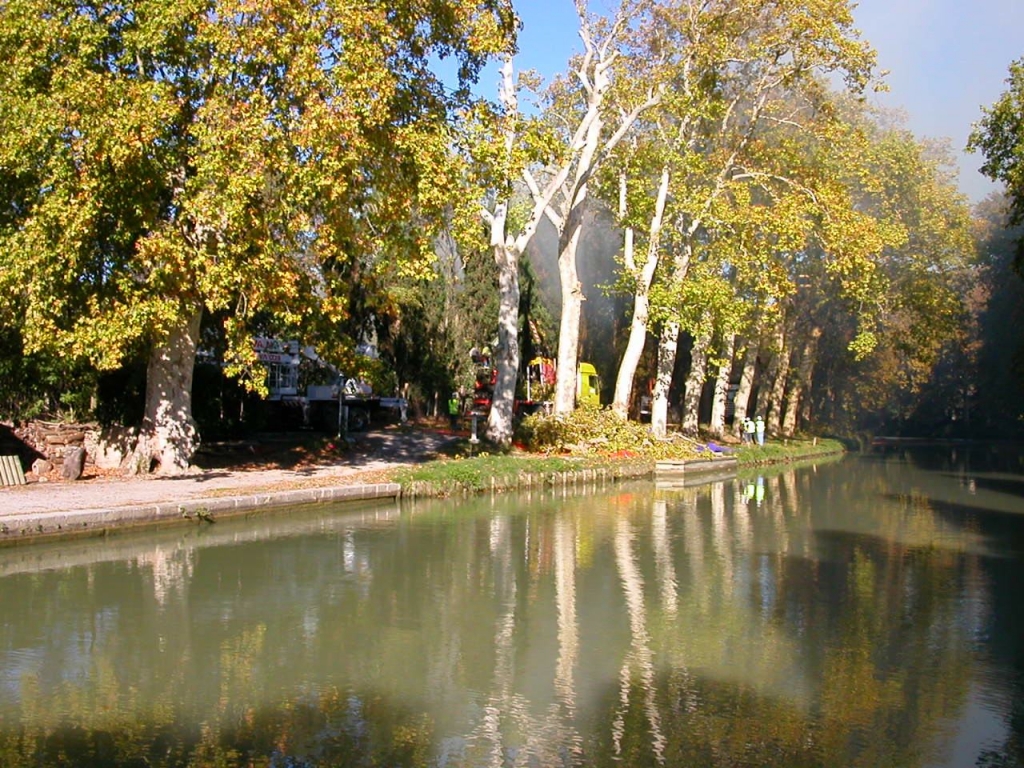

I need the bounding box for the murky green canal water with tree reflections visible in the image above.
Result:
[0,449,1024,768]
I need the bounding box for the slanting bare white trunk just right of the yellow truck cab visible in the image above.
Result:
[611,168,671,419]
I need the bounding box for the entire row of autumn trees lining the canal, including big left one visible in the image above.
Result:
[0,0,1021,472]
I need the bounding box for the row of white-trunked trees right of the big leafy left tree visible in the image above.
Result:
[470,0,1012,440]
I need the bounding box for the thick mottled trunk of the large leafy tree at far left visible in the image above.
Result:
[131,309,203,475]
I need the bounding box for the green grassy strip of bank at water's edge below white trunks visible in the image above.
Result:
[388,439,844,497]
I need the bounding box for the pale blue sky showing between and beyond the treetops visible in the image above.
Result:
[493,0,1024,203]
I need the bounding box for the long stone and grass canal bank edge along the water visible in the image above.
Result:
[0,440,844,547]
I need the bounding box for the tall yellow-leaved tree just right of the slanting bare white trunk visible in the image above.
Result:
[581,0,873,434]
